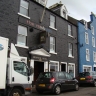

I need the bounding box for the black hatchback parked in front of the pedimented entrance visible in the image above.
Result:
[36,72,79,95]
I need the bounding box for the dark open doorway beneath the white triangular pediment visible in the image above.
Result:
[34,61,44,81]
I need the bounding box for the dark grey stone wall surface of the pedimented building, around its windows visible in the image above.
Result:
[0,0,78,74]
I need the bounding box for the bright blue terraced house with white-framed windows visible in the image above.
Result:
[78,12,96,72]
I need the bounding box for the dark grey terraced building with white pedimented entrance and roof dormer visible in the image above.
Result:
[0,0,78,81]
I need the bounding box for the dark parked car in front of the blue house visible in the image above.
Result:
[76,71,96,87]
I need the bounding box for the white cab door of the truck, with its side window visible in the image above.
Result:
[10,60,29,87]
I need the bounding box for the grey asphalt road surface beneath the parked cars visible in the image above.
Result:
[29,86,96,96]
